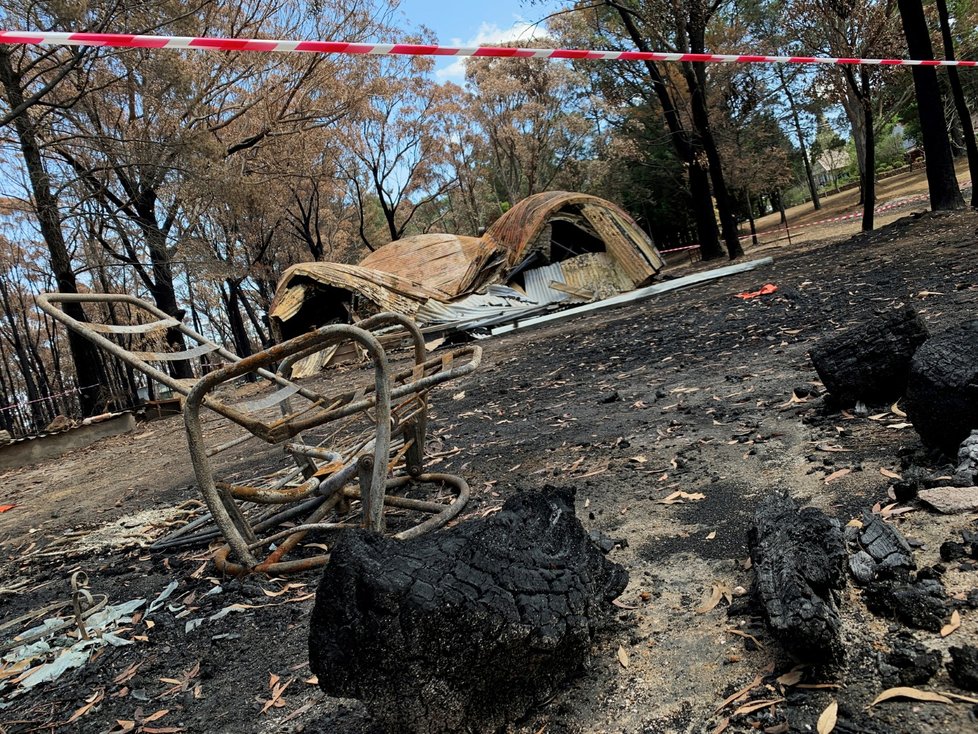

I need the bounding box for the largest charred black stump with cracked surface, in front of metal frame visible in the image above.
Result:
[309,488,628,732]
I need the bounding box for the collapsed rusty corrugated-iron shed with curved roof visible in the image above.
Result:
[271,191,662,338]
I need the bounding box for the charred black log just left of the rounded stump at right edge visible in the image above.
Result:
[809,306,927,403]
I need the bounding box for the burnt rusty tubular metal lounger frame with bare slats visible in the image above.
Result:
[37,293,482,574]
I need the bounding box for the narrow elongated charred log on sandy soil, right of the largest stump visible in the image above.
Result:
[747,494,846,661]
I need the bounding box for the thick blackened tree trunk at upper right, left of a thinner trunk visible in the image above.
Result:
[898,0,964,211]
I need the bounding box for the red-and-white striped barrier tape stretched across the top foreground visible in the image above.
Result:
[0,31,978,66]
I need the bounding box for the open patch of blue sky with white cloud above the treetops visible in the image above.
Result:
[398,0,560,82]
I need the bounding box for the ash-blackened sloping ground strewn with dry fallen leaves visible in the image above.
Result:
[0,212,978,734]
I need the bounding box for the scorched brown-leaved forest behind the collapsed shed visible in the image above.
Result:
[0,0,978,437]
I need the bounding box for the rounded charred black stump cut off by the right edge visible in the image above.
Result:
[907,321,978,457]
